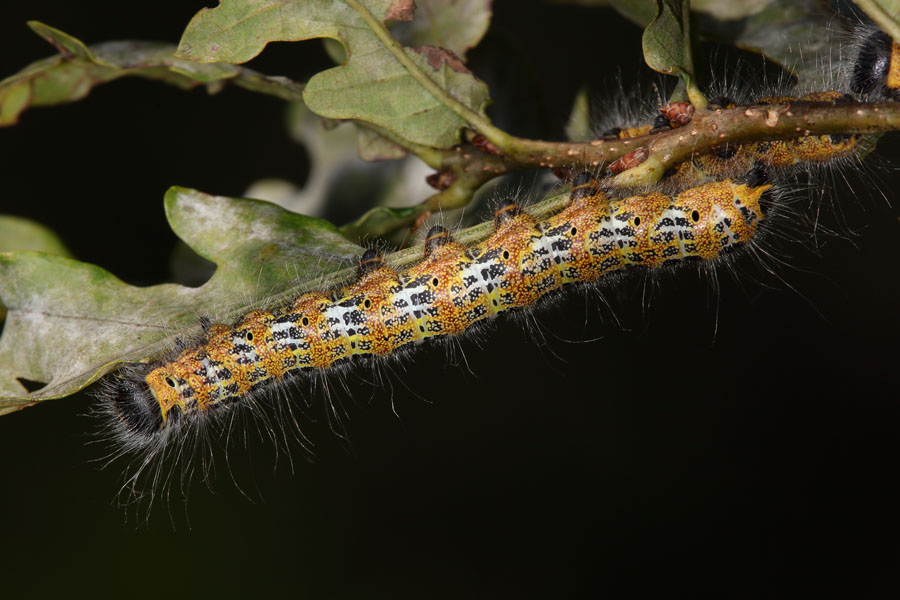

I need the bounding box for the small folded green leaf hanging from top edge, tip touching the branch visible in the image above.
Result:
[642,0,706,108]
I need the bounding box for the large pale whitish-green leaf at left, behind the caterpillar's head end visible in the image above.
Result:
[0,187,363,411]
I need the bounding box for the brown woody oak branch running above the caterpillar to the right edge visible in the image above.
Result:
[342,101,900,237]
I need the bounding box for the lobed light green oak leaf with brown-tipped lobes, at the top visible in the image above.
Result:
[177,0,489,148]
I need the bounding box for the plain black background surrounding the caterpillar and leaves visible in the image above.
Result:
[0,0,900,598]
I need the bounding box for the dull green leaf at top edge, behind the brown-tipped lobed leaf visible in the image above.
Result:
[391,0,492,61]
